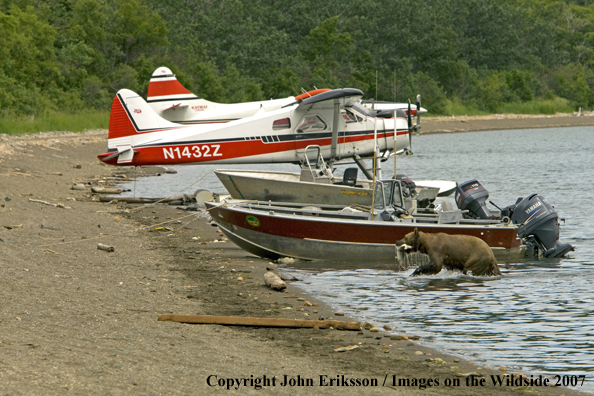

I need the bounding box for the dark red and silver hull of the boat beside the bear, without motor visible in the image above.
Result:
[206,201,525,261]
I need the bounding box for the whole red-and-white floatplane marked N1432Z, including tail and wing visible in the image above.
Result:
[98,88,412,172]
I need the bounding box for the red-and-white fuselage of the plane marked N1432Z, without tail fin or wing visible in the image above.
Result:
[99,96,408,166]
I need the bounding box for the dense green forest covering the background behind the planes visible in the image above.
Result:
[0,0,594,117]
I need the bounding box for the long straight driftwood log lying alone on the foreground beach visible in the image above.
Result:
[157,314,361,331]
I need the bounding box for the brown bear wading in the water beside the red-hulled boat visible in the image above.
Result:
[396,228,501,276]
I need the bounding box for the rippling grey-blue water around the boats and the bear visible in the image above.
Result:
[119,127,594,393]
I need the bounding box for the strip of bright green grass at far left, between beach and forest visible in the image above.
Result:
[0,110,109,135]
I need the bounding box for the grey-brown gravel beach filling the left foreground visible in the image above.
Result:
[0,117,594,395]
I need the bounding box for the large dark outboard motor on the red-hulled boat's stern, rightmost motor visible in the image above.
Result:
[511,194,574,258]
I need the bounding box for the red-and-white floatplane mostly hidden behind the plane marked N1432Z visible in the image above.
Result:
[146,66,427,124]
